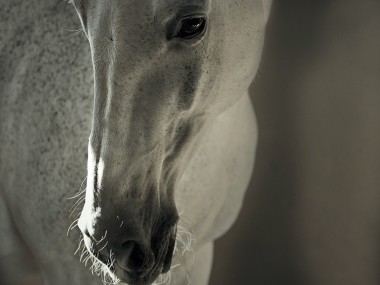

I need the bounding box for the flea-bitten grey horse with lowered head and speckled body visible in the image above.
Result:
[0,0,270,285]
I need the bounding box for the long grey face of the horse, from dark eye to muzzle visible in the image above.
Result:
[74,0,264,284]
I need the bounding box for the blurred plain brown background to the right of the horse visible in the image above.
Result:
[210,0,380,285]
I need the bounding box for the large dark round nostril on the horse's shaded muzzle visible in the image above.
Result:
[118,241,154,274]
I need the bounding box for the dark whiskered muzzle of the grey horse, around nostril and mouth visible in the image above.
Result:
[80,212,178,285]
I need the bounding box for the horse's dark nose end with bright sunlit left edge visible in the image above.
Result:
[78,207,179,284]
